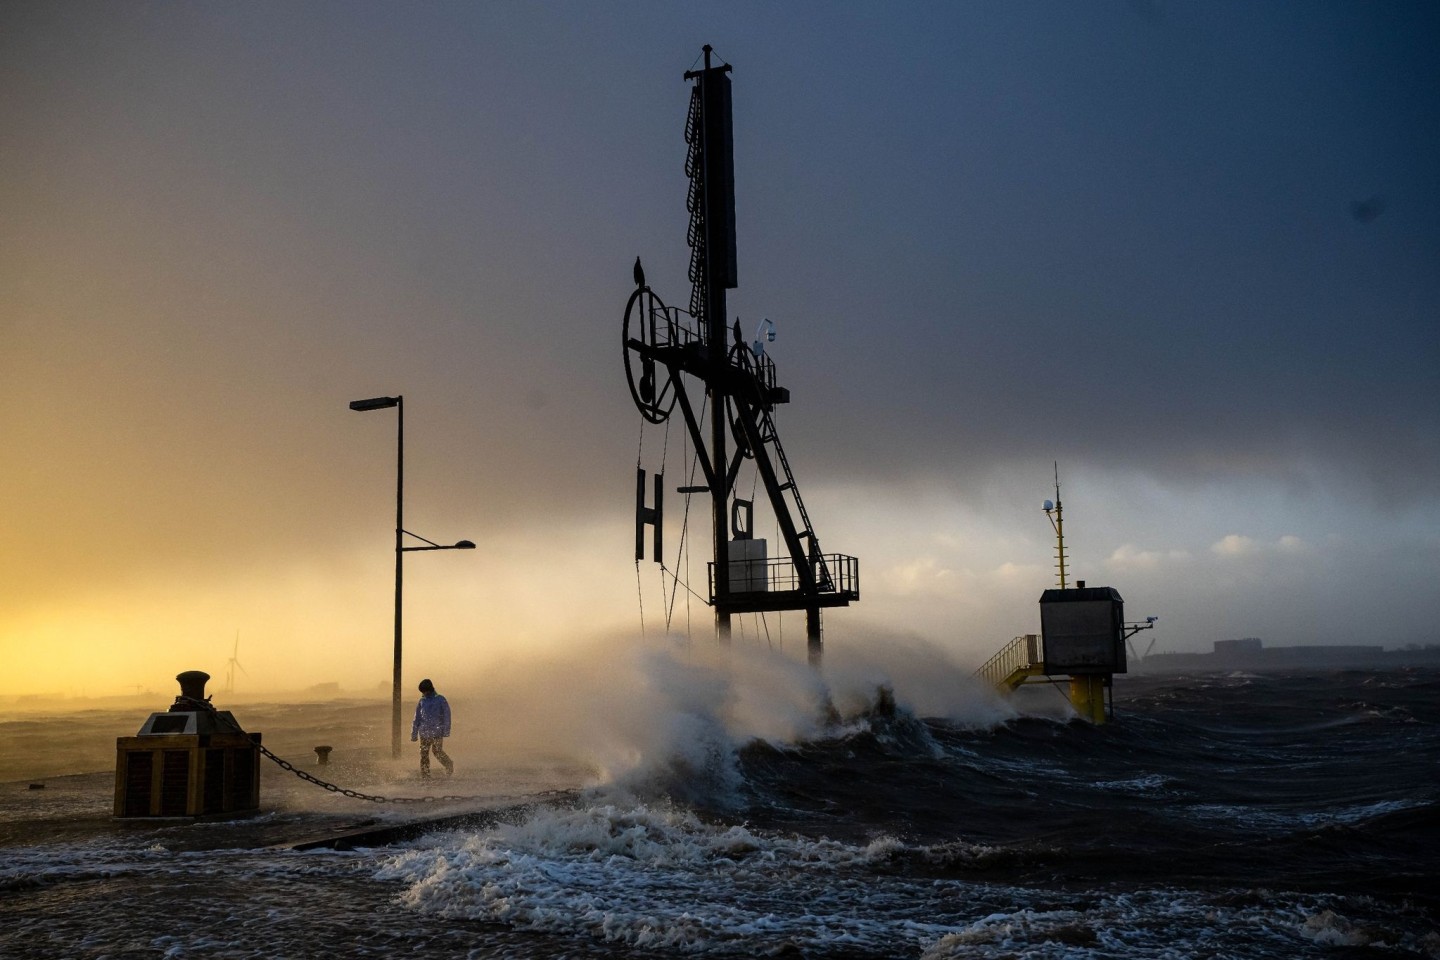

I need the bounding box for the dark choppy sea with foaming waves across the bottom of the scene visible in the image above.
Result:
[0,665,1440,960]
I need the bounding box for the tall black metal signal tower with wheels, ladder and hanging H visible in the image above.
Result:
[624,46,860,665]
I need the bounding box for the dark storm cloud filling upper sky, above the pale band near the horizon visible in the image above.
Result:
[0,3,1440,630]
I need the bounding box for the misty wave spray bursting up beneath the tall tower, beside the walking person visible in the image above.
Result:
[434,638,1015,809]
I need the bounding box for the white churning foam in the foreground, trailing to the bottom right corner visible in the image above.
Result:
[377,805,1411,960]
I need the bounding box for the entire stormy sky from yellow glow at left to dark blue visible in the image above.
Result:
[0,1,1440,695]
